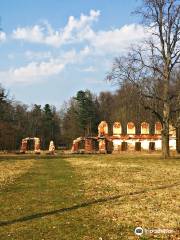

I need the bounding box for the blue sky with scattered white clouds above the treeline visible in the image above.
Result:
[0,0,145,106]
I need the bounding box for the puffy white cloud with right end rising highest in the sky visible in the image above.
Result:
[12,10,100,47]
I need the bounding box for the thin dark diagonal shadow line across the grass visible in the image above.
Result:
[0,182,180,227]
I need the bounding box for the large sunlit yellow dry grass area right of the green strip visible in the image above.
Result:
[68,155,180,239]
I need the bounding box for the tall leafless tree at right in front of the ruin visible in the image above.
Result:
[108,0,180,158]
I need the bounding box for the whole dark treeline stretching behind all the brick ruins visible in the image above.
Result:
[0,78,180,151]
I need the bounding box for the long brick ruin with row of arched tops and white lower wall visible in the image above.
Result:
[71,121,180,153]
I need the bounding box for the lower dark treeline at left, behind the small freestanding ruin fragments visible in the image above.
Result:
[0,87,61,151]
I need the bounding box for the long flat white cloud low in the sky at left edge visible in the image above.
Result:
[0,49,81,84]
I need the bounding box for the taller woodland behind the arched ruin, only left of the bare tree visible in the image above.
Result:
[61,84,157,145]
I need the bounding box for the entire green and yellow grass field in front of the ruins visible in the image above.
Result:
[0,154,180,240]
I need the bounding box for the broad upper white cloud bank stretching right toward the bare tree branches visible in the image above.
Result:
[13,10,148,54]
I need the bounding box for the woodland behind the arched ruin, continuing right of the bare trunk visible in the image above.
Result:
[61,71,180,144]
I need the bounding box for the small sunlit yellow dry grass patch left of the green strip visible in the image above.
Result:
[0,159,35,189]
